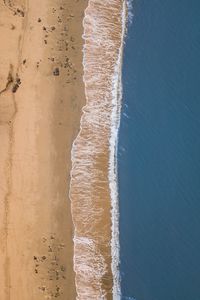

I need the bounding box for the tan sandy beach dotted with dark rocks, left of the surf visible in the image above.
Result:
[0,0,87,300]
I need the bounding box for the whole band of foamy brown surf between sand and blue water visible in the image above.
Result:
[70,0,126,300]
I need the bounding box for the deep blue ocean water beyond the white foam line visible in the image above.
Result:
[118,0,200,300]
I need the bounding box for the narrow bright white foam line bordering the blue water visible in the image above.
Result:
[109,1,126,300]
